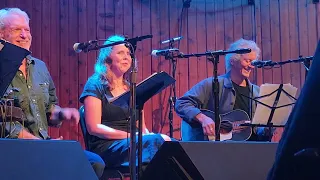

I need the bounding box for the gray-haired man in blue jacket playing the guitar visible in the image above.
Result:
[175,39,266,141]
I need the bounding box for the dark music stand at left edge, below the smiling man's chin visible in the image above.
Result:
[0,39,31,98]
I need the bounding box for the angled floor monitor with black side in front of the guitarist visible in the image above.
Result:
[141,141,278,180]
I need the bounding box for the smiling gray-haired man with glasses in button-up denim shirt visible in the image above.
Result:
[0,8,105,176]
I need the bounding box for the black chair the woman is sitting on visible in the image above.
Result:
[79,106,130,180]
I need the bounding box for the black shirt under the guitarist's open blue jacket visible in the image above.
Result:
[232,82,251,118]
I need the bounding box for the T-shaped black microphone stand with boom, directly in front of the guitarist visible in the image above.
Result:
[173,49,251,141]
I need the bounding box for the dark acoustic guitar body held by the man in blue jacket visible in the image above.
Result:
[201,109,252,141]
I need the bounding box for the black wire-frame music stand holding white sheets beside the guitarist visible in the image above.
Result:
[241,84,297,142]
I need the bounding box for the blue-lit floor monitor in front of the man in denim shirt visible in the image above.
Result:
[0,139,98,180]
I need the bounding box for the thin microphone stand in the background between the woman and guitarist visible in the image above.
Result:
[165,41,177,137]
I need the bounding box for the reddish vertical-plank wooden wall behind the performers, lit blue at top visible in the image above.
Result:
[0,0,320,146]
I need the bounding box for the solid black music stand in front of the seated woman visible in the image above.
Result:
[109,71,176,175]
